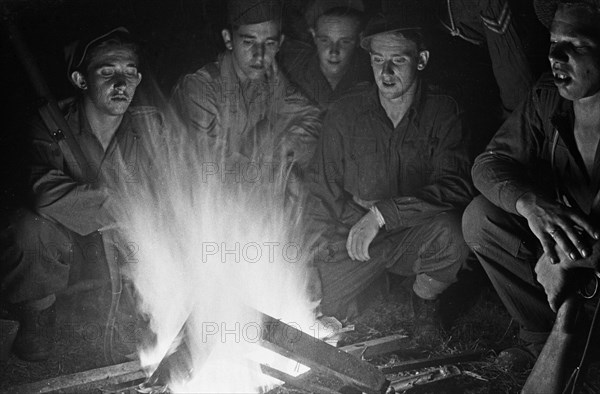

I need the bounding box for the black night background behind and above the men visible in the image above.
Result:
[0,0,547,225]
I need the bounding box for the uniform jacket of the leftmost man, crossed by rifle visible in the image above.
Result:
[31,101,163,235]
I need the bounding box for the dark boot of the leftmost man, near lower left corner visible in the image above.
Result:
[13,303,56,361]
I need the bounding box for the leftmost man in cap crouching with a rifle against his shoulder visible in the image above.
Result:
[0,27,163,361]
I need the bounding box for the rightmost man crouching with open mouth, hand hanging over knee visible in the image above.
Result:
[463,0,600,378]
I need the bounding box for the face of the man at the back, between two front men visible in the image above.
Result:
[311,16,360,81]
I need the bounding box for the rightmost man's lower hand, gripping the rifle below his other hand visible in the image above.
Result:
[535,253,569,312]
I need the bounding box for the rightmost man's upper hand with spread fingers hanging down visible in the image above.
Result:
[516,193,600,264]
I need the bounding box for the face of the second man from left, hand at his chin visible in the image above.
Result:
[222,21,283,80]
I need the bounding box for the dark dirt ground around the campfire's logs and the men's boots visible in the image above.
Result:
[0,270,600,394]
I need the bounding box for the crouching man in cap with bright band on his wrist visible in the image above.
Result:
[311,12,472,336]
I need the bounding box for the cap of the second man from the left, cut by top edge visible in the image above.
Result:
[227,0,282,26]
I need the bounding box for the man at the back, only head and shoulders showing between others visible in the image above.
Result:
[281,0,373,109]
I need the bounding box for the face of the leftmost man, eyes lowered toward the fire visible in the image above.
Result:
[80,45,142,116]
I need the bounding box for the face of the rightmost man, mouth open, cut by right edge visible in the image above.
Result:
[548,5,600,100]
